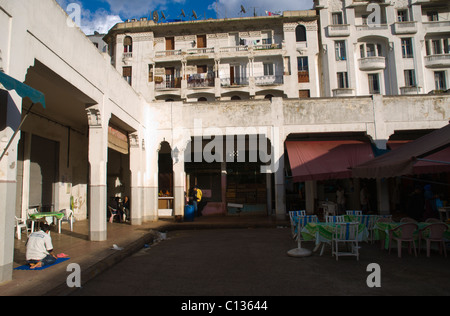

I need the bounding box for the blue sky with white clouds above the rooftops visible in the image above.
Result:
[56,0,313,35]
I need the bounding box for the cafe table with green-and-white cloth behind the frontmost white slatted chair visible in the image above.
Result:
[301,222,369,251]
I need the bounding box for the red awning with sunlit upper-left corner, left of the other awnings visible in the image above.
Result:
[286,140,374,182]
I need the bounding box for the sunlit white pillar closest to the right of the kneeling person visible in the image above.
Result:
[87,108,108,241]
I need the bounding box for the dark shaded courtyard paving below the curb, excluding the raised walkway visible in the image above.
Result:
[73,228,450,297]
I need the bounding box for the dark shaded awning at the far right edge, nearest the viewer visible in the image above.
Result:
[352,124,450,178]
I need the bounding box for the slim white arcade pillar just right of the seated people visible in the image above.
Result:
[129,133,144,225]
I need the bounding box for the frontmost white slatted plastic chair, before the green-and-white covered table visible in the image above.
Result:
[331,223,359,261]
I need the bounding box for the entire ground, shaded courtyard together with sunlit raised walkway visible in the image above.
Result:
[0,217,450,297]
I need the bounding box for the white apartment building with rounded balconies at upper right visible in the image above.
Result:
[314,0,450,96]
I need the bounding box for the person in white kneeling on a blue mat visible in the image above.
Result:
[26,224,57,269]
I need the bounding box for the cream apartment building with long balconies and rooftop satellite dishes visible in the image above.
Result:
[105,11,320,102]
